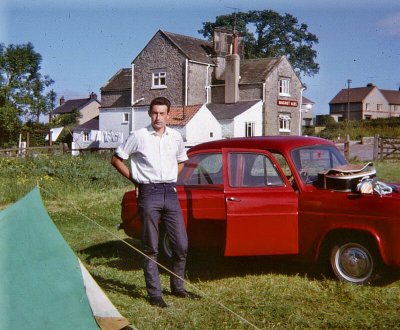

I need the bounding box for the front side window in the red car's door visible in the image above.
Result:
[229,152,284,187]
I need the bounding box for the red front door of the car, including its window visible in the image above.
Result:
[223,149,298,256]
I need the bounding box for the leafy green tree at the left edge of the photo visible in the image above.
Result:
[0,43,53,147]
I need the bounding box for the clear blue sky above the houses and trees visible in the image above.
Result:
[0,0,400,114]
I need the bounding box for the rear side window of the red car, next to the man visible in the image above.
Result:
[178,153,223,185]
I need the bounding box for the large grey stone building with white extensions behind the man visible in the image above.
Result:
[99,29,305,147]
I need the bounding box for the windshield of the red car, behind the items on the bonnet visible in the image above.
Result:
[292,146,347,183]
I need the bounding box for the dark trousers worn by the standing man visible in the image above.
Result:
[139,183,188,297]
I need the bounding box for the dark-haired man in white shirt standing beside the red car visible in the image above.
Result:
[111,97,199,308]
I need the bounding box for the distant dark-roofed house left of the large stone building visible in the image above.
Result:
[53,93,100,125]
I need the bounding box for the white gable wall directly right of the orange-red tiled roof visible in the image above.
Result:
[182,105,222,144]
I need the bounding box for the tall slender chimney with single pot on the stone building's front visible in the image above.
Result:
[225,33,240,103]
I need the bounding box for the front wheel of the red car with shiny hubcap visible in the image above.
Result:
[330,240,378,284]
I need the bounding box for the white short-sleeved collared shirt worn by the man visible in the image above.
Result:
[115,125,188,184]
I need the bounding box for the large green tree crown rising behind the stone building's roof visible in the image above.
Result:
[198,10,319,76]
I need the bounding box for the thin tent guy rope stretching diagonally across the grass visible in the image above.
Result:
[37,186,260,330]
